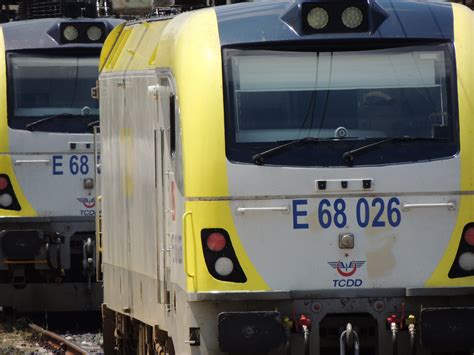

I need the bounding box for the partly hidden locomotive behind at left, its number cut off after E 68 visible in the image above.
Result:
[0,2,122,311]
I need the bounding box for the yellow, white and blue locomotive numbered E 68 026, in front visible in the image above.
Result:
[99,0,474,354]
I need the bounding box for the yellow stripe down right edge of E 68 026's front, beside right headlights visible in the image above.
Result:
[426,4,474,287]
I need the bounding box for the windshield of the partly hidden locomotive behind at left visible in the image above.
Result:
[8,53,99,133]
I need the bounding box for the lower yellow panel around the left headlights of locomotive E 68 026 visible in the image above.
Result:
[183,201,270,292]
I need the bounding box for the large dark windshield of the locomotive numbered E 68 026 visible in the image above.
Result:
[224,44,457,166]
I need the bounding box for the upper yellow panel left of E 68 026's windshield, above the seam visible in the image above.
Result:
[169,9,229,197]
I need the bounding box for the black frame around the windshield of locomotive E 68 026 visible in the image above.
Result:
[222,39,460,167]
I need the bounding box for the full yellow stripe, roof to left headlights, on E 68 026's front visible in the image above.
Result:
[168,9,269,292]
